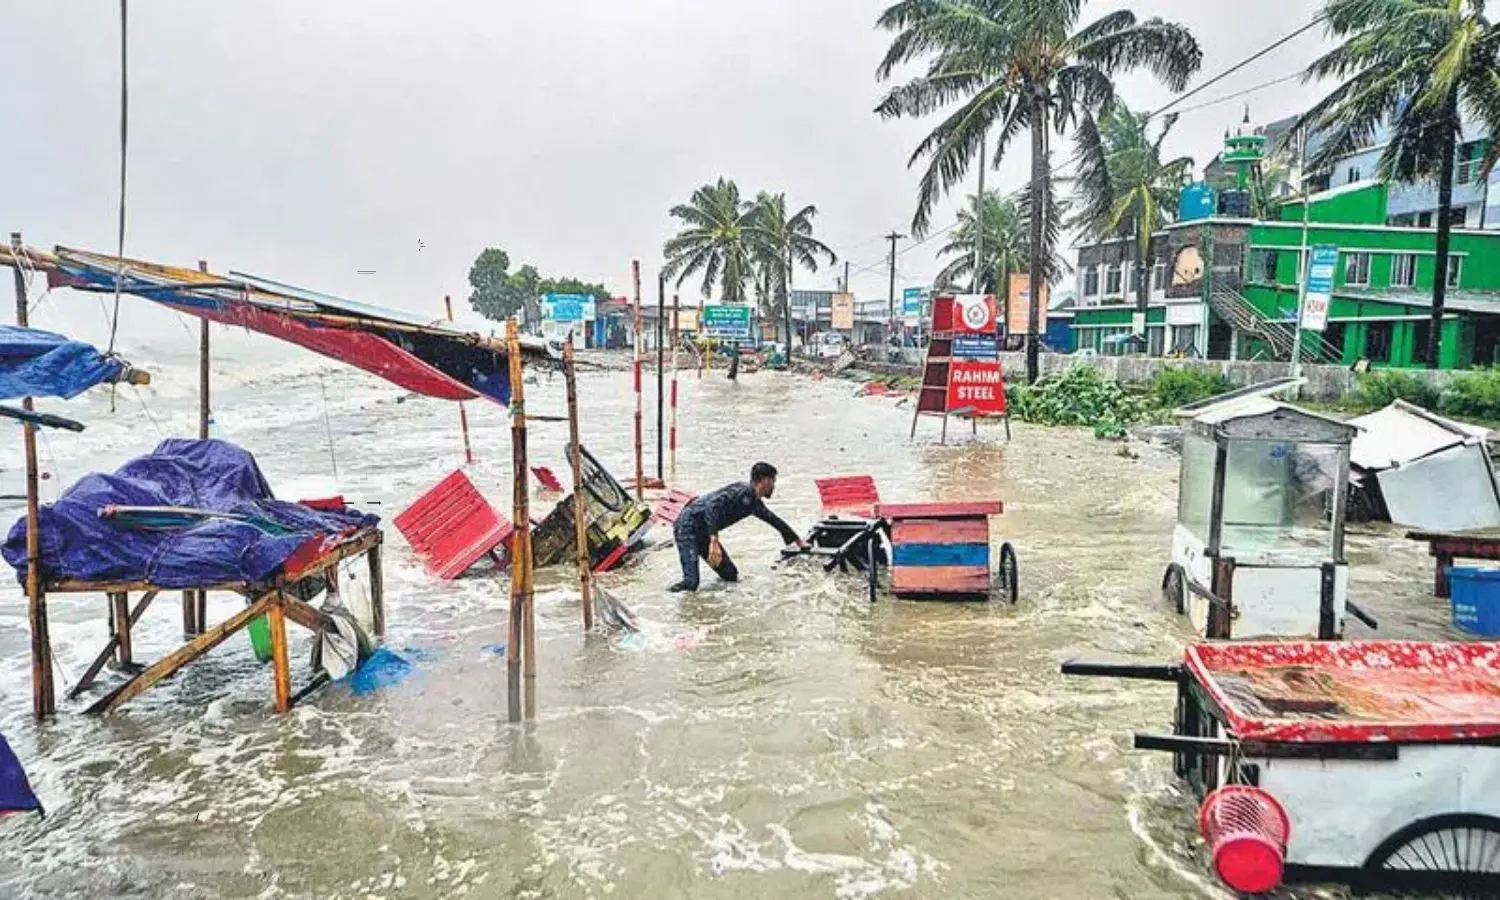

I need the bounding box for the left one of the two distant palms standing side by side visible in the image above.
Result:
[662,179,759,303]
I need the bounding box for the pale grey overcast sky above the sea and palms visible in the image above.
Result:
[0,0,1323,349]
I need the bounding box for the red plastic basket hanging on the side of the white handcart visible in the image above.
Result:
[1199,785,1292,894]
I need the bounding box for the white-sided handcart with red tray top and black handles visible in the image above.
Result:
[1062,641,1500,897]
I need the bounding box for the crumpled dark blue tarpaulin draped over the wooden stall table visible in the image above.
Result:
[3,438,380,588]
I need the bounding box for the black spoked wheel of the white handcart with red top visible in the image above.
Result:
[1364,813,1500,900]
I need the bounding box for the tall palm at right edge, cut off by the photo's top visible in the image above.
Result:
[1298,0,1500,369]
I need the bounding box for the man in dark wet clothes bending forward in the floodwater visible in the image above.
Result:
[668,462,807,591]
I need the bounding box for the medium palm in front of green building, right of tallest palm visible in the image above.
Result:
[1073,104,1193,347]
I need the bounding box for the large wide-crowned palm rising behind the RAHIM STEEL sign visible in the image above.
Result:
[876,0,1203,381]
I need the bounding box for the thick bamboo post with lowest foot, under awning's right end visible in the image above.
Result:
[506,320,534,722]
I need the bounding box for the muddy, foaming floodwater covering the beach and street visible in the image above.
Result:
[0,355,1451,900]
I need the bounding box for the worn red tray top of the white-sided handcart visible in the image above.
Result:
[1187,641,1500,744]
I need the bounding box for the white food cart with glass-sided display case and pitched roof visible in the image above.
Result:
[1161,384,1374,639]
